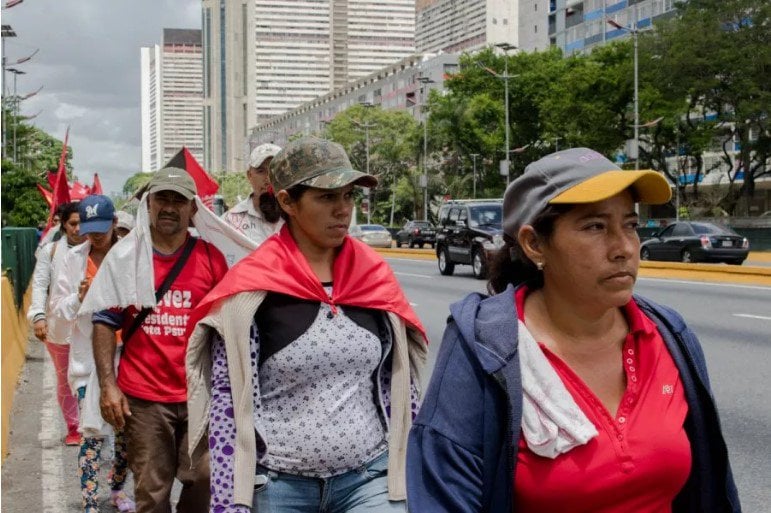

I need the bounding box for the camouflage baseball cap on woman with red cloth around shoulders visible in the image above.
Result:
[270,137,377,191]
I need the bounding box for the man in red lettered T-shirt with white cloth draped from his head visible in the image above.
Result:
[78,167,256,513]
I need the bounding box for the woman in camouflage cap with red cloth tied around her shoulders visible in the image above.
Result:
[187,137,426,512]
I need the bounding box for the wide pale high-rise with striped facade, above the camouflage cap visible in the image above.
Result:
[202,0,415,171]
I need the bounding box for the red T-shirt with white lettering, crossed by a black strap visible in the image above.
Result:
[118,239,228,403]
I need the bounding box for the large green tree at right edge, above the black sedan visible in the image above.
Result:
[641,0,771,214]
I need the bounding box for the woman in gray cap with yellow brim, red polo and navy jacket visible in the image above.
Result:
[407,148,740,513]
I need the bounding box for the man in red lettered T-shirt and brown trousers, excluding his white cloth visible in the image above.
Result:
[92,168,227,513]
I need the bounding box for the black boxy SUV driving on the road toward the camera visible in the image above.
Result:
[436,199,503,279]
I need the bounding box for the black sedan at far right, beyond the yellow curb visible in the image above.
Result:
[640,221,750,265]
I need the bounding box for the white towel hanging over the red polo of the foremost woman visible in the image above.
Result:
[518,321,598,459]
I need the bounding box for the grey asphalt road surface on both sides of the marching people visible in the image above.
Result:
[2,259,771,513]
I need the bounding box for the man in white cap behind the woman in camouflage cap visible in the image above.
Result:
[222,143,284,244]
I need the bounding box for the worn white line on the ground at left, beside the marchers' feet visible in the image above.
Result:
[39,351,67,513]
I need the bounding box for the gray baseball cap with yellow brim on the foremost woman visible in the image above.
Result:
[503,148,672,238]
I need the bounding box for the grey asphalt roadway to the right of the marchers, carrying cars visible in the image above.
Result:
[388,259,771,513]
